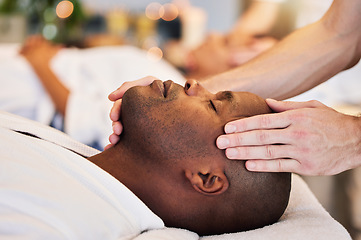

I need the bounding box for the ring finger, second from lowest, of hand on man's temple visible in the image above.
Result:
[226,145,293,160]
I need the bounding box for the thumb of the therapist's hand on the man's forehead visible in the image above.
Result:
[266,99,325,112]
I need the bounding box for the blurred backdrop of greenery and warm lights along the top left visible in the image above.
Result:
[0,0,242,47]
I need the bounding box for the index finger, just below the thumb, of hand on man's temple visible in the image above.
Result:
[224,112,291,133]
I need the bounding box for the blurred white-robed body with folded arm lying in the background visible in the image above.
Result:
[0,36,185,150]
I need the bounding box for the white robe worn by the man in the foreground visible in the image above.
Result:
[0,123,164,240]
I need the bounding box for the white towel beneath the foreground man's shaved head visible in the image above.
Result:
[129,174,351,240]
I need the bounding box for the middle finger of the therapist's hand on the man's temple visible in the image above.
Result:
[216,129,289,149]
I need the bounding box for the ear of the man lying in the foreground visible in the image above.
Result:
[185,169,229,195]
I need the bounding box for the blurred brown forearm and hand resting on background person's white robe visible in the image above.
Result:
[20,36,70,116]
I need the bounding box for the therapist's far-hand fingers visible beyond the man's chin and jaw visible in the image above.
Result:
[105,76,158,149]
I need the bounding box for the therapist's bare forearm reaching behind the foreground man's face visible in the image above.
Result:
[202,0,361,99]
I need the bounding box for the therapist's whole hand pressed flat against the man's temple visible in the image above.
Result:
[217,99,361,175]
